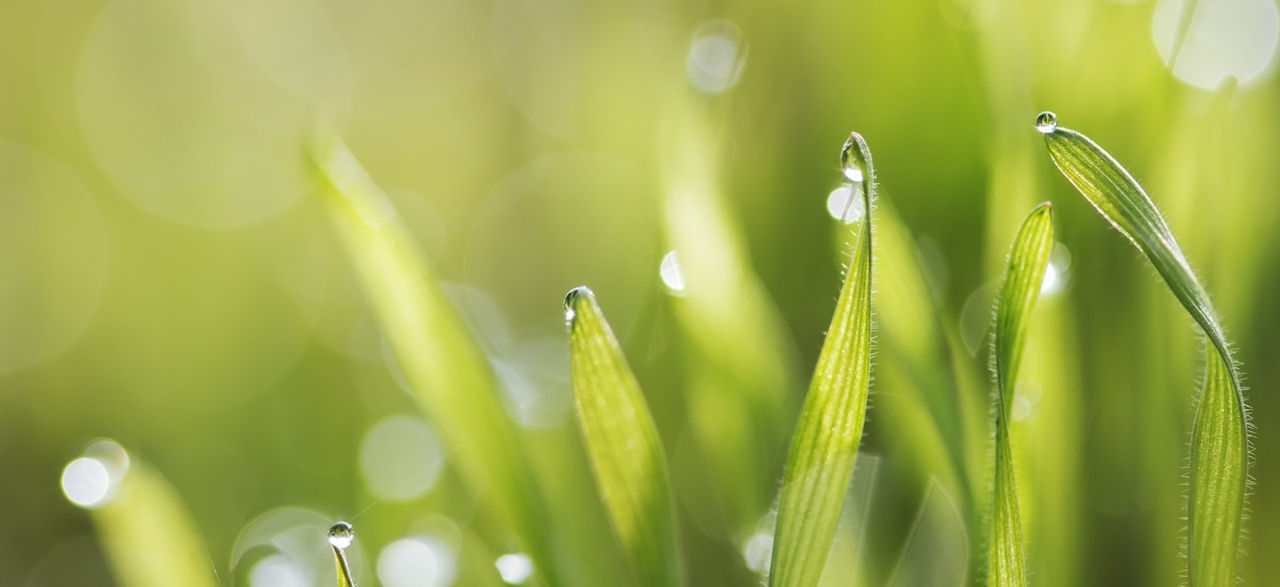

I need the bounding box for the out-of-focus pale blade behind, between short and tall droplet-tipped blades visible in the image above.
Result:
[658,100,797,532]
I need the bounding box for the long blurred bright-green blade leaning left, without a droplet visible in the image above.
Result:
[311,137,558,584]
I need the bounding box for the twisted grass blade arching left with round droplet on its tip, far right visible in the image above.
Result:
[1037,113,1249,586]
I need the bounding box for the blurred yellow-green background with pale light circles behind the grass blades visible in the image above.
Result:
[0,0,1280,587]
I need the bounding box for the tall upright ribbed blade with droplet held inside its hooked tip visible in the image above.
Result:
[769,133,876,586]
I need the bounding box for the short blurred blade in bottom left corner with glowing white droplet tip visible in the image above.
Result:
[63,440,218,587]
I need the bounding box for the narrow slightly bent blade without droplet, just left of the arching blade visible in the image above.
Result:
[987,203,1053,587]
